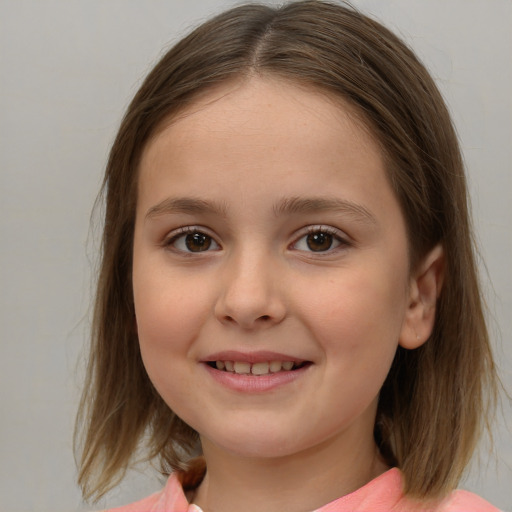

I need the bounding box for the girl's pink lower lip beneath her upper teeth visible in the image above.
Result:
[204,364,311,393]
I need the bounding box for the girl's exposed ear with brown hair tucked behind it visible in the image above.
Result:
[399,245,445,349]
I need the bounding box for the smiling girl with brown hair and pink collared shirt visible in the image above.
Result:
[75,0,496,512]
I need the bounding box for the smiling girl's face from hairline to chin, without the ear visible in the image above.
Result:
[133,79,409,457]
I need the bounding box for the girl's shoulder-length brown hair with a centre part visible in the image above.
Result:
[76,0,497,499]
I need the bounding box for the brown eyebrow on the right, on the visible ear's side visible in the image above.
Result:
[274,197,377,224]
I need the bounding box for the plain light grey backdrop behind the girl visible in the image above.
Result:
[0,0,512,512]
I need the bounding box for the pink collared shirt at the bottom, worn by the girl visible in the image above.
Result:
[105,468,499,512]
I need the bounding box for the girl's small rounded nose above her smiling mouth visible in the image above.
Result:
[215,250,286,330]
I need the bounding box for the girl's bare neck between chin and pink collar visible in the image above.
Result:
[194,428,388,512]
